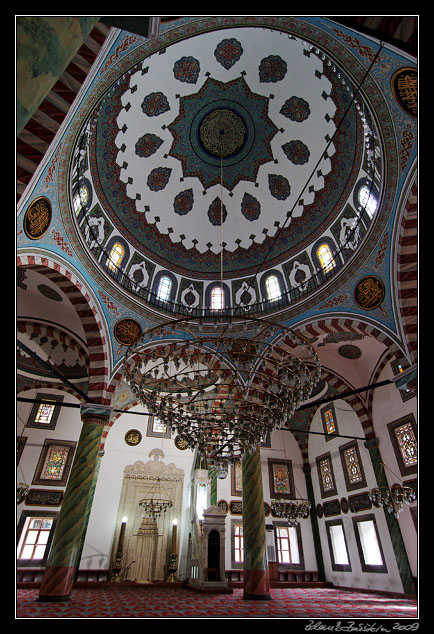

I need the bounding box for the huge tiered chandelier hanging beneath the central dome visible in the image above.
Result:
[123,311,320,464]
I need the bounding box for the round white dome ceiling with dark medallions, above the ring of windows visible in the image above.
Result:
[71,17,381,302]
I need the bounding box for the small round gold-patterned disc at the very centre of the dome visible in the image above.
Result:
[199,108,247,158]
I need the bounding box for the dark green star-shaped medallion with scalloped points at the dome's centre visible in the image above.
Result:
[168,77,278,190]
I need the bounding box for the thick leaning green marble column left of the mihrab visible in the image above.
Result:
[37,408,110,601]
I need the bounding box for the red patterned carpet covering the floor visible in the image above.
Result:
[16,587,418,622]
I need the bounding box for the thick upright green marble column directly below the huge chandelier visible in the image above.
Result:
[242,447,272,600]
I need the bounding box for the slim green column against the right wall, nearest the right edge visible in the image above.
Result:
[365,438,416,594]
